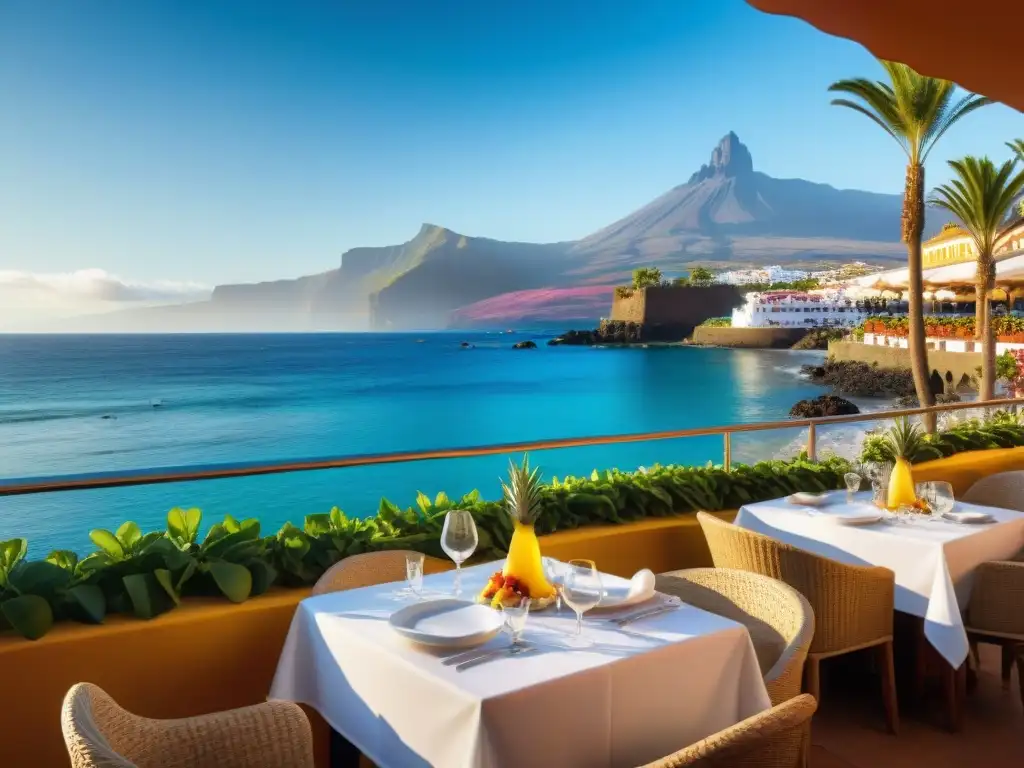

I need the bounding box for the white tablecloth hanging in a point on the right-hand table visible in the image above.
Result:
[735,499,1024,668]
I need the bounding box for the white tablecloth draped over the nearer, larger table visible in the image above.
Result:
[269,563,769,768]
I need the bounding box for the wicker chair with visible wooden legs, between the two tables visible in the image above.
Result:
[697,512,899,733]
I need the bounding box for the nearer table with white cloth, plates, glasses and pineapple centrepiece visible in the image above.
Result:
[269,461,770,768]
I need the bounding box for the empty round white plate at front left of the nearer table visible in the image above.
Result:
[388,597,505,648]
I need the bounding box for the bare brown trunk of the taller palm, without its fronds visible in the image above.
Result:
[902,163,936,432]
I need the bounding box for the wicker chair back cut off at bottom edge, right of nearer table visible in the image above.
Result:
[644,693,818,768]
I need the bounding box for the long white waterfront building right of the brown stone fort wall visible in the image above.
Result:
[732,291,869,328]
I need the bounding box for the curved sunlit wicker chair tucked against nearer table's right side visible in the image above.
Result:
[655,568,814,705]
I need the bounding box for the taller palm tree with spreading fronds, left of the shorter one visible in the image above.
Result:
[828,59,989,431]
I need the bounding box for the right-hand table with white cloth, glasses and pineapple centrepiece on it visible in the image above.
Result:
[734,468,1024,669]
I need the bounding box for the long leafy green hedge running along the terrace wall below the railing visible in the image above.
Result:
[6,413,1024,639]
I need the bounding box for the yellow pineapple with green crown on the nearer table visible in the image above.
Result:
[502,456,555,599]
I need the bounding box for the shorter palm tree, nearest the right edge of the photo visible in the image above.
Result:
[928,157,1024,400]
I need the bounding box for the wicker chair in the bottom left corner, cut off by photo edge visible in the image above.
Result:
[60,683,313,768]
